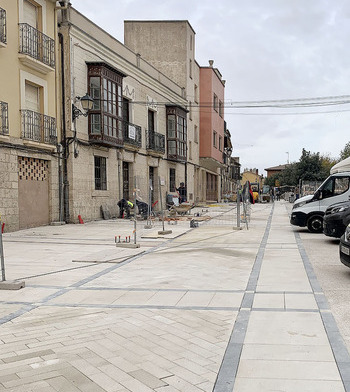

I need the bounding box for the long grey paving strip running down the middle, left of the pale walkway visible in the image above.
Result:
[213,205,274,392]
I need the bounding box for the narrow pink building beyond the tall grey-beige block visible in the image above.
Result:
[199,60,225,201]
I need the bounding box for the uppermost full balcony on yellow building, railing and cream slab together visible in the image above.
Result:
[19,23,55,74]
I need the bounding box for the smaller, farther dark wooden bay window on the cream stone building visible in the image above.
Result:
[167,107,187,161]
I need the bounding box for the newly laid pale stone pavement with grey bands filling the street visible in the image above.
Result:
[0,201,350,392]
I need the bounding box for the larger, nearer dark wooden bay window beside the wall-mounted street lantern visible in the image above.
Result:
[88,63,125,141]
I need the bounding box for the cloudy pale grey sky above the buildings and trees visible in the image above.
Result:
[71,0,350,174]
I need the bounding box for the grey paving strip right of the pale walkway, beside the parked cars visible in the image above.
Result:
[294,232,350,392]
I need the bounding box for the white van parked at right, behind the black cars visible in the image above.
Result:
[290,158,350,233]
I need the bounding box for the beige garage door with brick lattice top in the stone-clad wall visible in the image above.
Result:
[18,157,50,229]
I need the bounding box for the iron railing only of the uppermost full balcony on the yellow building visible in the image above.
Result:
[19,23,55,68]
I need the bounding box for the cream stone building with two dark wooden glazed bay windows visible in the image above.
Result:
[59,7,189,222]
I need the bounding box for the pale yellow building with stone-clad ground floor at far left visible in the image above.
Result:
[0,0,60,231]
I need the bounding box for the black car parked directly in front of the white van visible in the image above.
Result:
[323,201,350,238]
